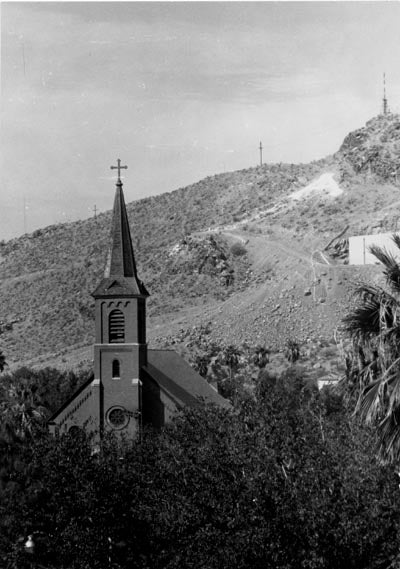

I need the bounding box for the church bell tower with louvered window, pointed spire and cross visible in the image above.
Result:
[92,159,149,435]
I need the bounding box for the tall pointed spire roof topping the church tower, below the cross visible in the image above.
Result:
[93,178,149,297]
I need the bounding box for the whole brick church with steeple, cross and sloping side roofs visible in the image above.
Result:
[49,160,230,436]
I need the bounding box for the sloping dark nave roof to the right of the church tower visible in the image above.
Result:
[144,350,231,408]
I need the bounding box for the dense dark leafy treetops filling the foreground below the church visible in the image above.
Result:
[0,373,400,569]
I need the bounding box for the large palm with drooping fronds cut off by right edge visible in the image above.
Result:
[343,235,400,463]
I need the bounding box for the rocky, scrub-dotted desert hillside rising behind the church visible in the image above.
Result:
[0,114,400,366]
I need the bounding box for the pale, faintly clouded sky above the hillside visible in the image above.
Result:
[0,1,400,240]
